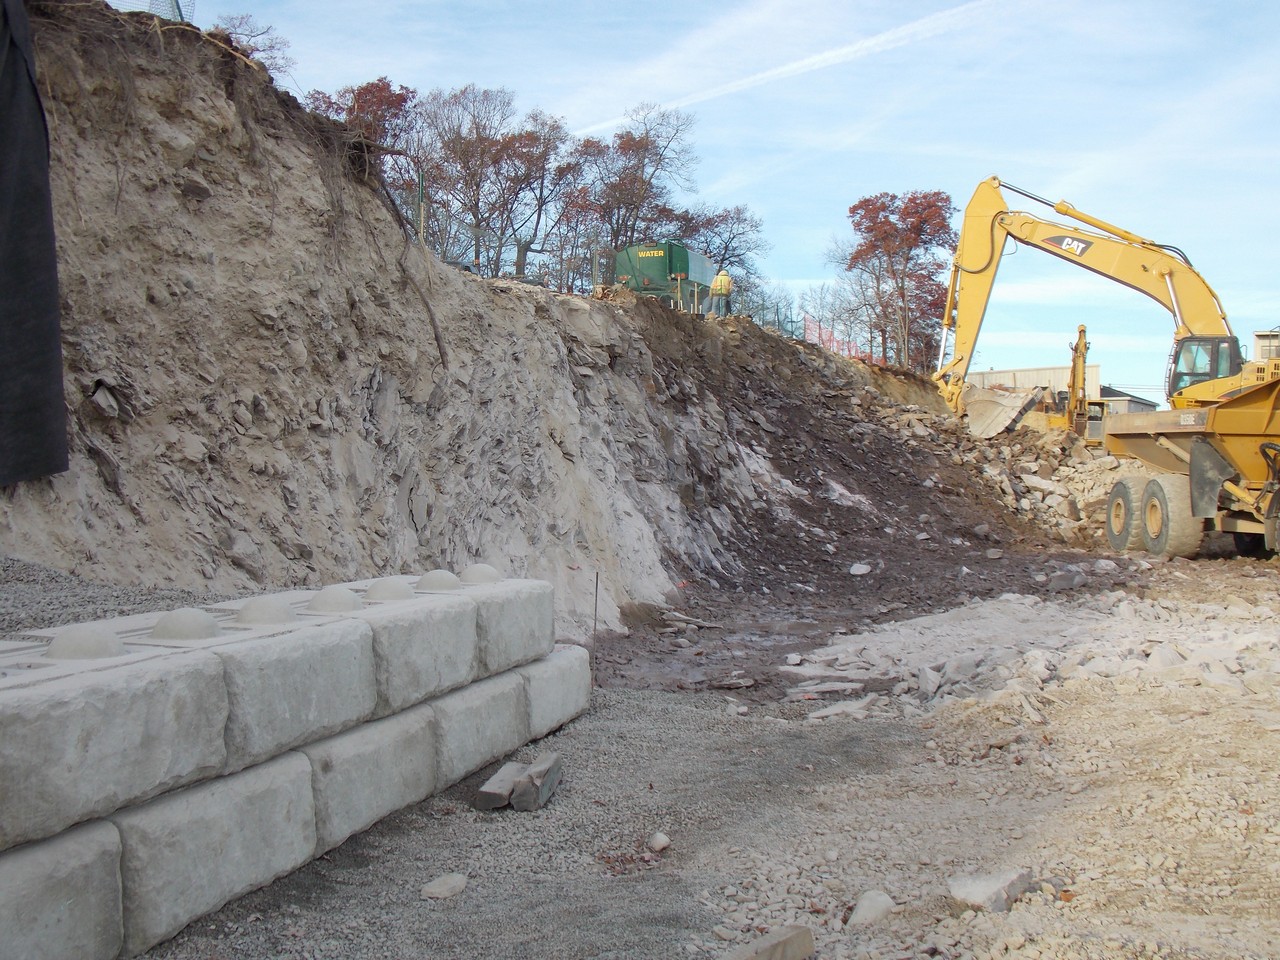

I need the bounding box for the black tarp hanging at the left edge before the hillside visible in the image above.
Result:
[0,0,67,486]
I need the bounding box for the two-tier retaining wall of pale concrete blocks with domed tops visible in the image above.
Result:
[0,577,591,960]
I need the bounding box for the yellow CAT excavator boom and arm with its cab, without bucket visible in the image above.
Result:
[933,177,1242,412]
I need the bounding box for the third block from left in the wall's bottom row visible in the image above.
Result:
[301,705,435,855]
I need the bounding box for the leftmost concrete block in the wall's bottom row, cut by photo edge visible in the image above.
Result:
[0,820,124,960]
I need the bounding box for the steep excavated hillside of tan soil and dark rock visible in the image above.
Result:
[0,3,1080,647]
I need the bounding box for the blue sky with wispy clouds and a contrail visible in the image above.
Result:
[196,0,1280,399]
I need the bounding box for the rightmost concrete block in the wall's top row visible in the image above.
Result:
[465,580,556,677]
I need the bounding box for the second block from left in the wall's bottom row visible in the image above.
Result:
[110,753,316,956]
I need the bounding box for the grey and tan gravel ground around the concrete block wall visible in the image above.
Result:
[0,552,1280,960]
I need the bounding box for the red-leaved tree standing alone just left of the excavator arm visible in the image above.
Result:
[845,191,956,371]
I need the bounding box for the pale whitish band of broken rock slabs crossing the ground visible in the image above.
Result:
[780,568,1280,719]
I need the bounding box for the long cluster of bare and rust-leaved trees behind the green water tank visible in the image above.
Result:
[306,77,765,291]
